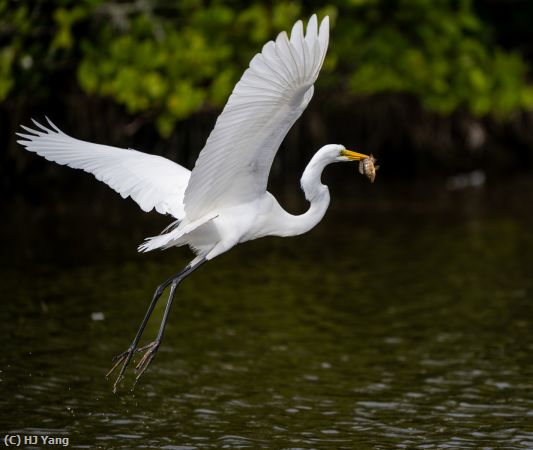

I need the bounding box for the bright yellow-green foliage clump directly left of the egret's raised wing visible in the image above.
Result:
[77,2,308,136]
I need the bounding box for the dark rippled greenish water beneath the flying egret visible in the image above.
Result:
[0,178,533,449]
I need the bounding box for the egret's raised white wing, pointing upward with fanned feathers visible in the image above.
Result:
[184,15,329,221]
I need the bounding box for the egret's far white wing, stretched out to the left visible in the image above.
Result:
[17,119,191,219]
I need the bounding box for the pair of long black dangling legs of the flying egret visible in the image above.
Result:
[106,259,206,392]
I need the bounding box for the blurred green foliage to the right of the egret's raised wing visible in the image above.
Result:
[335,0,533,116]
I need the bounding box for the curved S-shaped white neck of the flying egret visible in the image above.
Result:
[276,151,332,236]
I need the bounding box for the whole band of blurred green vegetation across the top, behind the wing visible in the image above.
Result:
[0,0,533,137]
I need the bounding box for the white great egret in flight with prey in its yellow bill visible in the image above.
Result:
[18,15,375,392]
